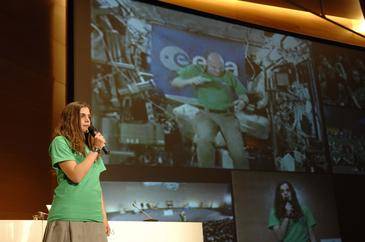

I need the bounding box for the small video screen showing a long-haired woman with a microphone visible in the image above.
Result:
[232,171,341,242]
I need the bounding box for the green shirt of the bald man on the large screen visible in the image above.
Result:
[178,65,246,110]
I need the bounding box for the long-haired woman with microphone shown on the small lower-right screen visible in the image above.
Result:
[268,181,316,242]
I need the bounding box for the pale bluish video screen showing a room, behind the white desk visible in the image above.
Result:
[102,181,235,242]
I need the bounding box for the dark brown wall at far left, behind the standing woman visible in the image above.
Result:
[0,0,52,219]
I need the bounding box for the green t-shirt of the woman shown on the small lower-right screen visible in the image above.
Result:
[268,207,316,242]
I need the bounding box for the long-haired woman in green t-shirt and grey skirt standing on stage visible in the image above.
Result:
[43,102,110,242]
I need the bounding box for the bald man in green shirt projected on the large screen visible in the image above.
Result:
[171,52,249,169]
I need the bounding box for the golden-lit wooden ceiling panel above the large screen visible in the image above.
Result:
[160,0,365,47]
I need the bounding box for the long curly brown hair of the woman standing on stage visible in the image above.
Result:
[54,102,91,156]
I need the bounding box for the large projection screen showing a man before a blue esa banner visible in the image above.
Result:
[73,0,365,172]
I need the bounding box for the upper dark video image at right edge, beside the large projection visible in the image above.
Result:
[313,43,365,109]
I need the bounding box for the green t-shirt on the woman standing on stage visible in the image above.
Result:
[48,136,106,222]
